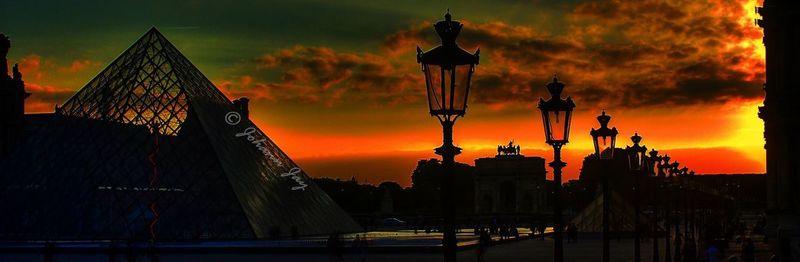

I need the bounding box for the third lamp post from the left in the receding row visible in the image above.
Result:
[589,110,619,262]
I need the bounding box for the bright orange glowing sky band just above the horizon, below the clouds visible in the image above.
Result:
[266,101,765,185]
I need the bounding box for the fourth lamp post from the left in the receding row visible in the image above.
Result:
[628,132,647,262]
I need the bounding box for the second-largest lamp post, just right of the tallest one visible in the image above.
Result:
[538,76,575,262]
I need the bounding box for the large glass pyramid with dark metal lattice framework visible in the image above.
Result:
[0,28,361,241]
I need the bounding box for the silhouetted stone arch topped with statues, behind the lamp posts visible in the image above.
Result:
[475,142,547,215]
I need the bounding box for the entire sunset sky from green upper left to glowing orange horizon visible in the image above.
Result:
[3,0,765,186]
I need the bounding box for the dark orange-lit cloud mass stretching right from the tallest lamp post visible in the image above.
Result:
[372,1,763,107]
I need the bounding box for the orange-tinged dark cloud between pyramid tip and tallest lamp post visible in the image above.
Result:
[227,46,424,106]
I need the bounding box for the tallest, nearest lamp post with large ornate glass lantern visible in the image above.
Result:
[417,10,480,262]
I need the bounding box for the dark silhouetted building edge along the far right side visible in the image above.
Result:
[757,0,800,261]
